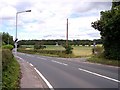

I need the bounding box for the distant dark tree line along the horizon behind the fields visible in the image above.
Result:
[18,39,102,46]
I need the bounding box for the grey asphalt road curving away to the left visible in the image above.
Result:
[14,53,120,90]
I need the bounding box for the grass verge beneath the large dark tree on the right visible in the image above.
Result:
[87,56,120,67]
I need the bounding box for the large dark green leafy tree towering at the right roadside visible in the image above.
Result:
[91,1,120,60]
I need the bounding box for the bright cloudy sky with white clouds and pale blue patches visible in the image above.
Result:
[0,0,111,40]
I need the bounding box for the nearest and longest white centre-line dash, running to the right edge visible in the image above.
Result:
[78,68,120,83]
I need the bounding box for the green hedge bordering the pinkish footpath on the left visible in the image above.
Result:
[2,50,20,90]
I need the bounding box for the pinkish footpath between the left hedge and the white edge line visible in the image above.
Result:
[16,57,48,90]
